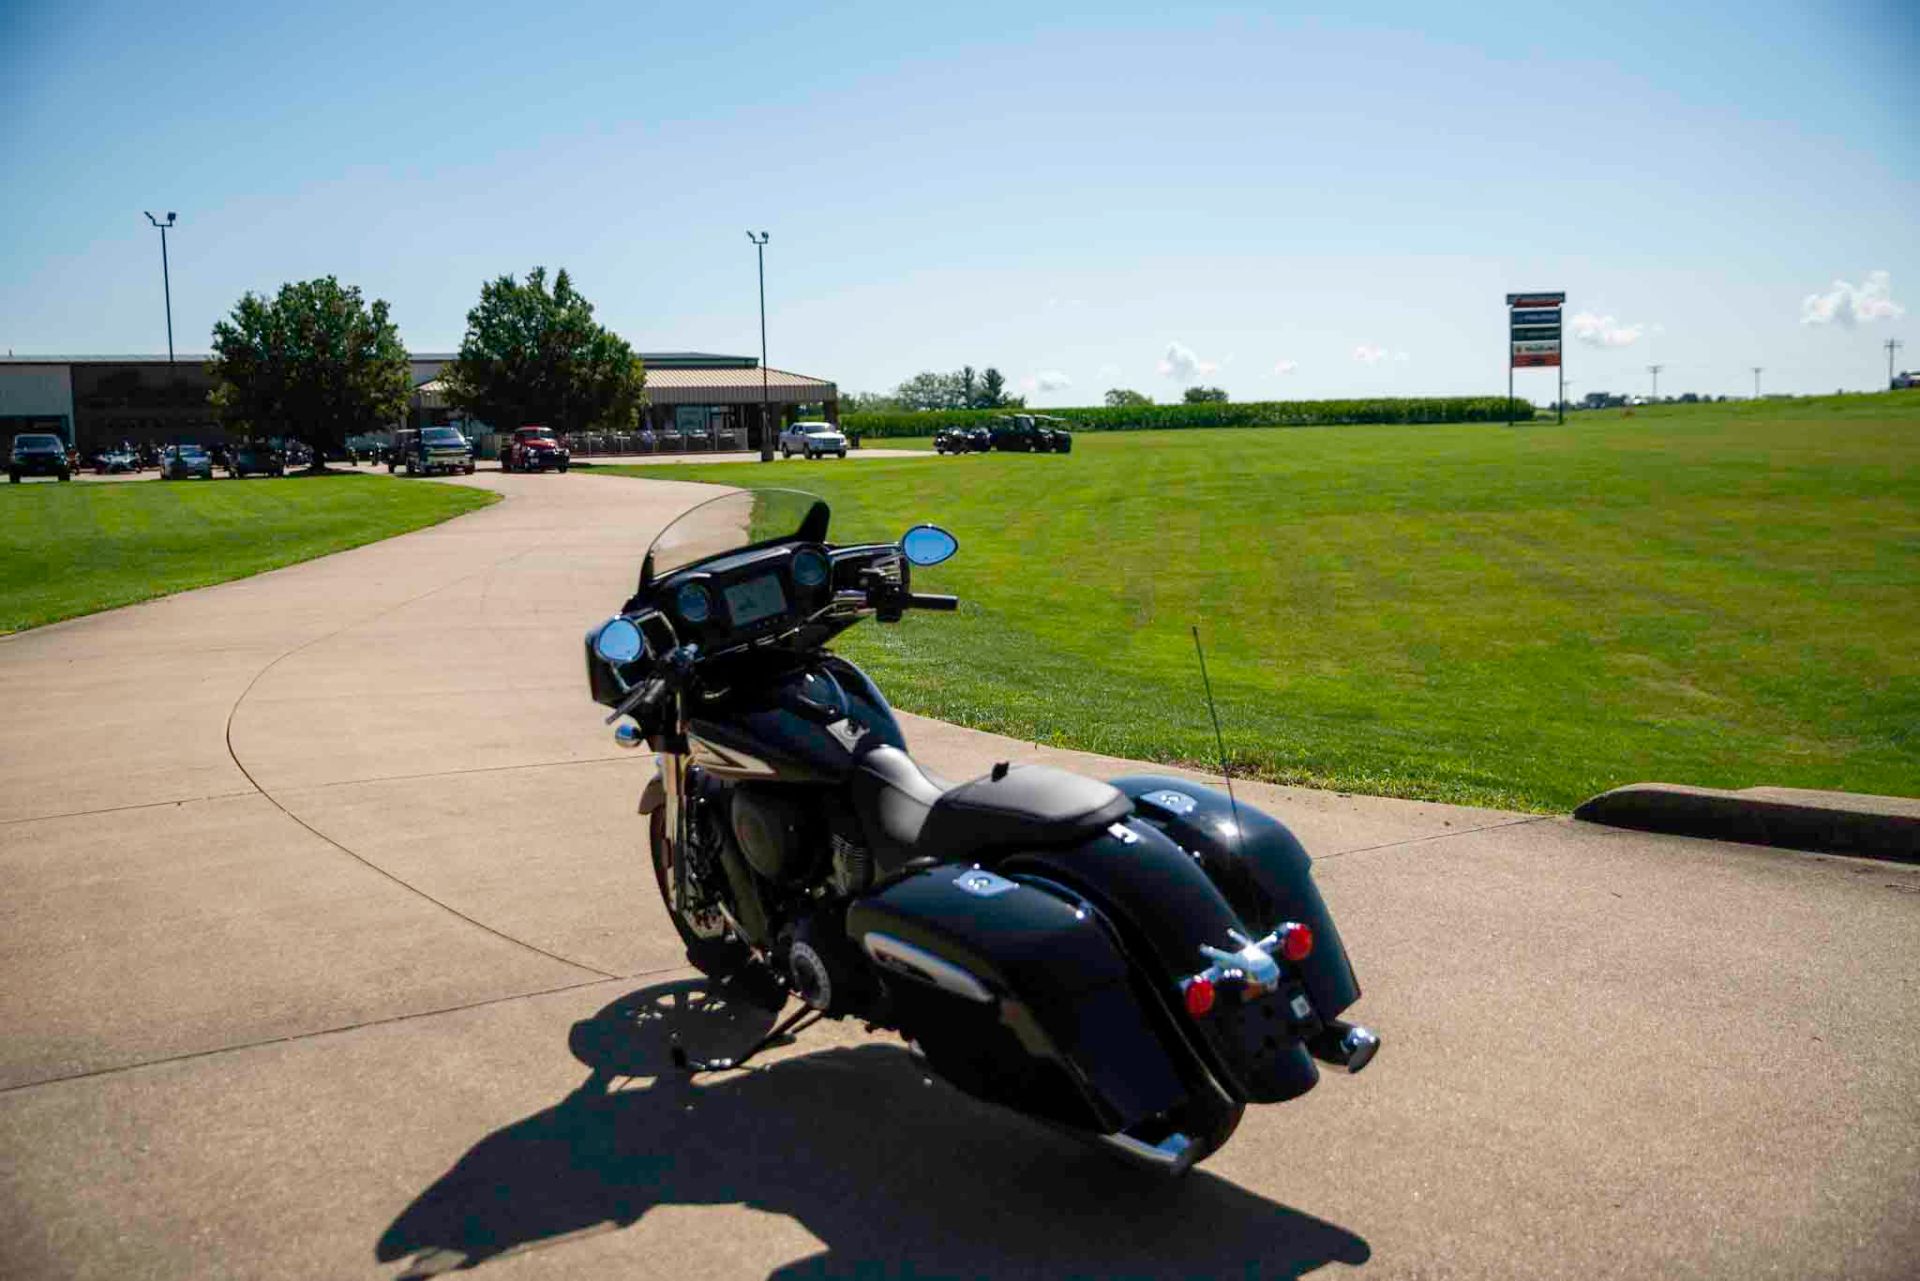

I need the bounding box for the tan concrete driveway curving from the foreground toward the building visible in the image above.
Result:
[0,472,1920,1277]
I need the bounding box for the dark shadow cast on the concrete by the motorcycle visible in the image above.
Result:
[374,979,1371,1279]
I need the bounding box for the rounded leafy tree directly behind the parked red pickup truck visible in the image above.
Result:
[440,267,647,432]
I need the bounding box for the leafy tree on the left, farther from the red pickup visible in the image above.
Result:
[207,277,413,471]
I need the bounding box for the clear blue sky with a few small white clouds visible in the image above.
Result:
[0,0,1920,405]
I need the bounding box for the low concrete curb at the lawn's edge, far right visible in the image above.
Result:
[1572,784,1920,862]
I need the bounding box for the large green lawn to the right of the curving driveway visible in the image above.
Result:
[599,396,1920,810]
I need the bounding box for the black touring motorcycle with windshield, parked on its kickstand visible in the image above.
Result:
[586,490,1379,1173]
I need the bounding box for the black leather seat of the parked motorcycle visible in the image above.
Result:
[852,747,1133,868]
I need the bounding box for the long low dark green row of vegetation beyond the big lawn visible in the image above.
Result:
[841,396,1534,440]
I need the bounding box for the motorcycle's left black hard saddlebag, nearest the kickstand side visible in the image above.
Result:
[847,864,1194,1133]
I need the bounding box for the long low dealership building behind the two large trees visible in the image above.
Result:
[0,351,839,453]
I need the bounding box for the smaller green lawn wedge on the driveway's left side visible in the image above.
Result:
[0,474,497,632]
